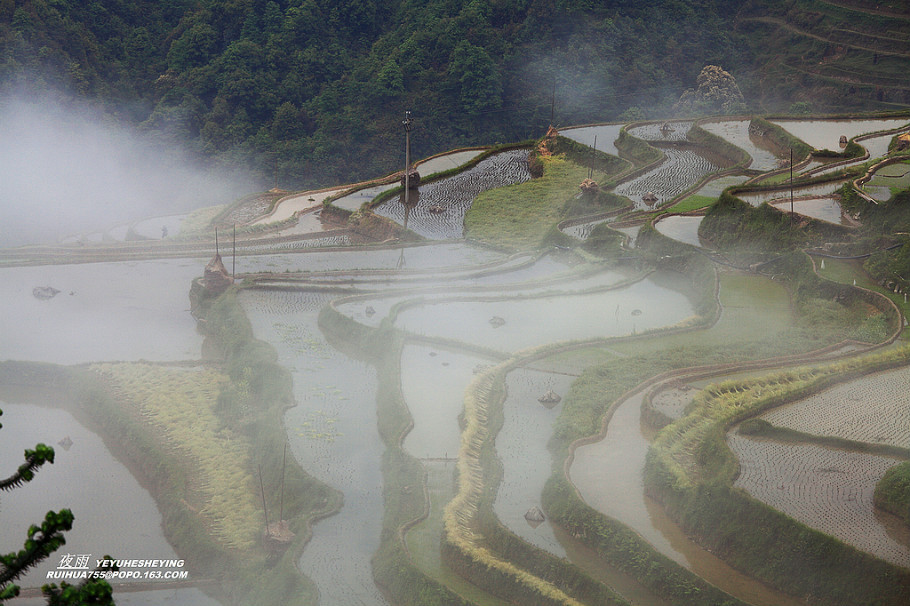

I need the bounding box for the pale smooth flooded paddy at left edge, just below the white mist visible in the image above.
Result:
[0,259,205,364]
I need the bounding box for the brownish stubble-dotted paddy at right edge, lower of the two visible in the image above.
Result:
[727,433,910,567]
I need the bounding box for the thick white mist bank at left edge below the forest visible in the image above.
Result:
[0,97,261,246]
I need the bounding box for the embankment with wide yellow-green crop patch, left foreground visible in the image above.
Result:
[87,290,340,605]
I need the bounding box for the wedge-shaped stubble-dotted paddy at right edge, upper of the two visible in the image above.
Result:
[761,368,910,447]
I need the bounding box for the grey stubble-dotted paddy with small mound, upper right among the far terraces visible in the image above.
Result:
[614,148,720,210]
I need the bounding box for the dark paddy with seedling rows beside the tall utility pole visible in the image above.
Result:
[374,150,531,240]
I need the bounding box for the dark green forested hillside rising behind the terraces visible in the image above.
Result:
[0,0,910,187]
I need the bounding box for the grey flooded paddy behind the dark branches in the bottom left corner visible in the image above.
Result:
[0,404,218,606]
